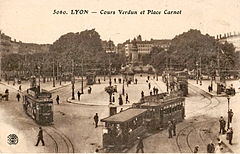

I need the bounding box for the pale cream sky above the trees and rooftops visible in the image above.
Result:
[0,0,240,44]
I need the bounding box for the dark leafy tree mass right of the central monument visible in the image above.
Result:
[143,29,240,73]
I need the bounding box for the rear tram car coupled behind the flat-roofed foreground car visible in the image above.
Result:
[133,93,185,131]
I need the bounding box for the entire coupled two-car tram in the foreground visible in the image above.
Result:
[101,93,185,152]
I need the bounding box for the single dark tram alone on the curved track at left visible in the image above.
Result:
[23,86,53,124]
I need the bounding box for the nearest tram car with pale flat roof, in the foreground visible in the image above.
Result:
[101,108,147,152]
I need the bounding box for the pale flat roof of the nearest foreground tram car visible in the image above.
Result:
[101,108,147,123]
